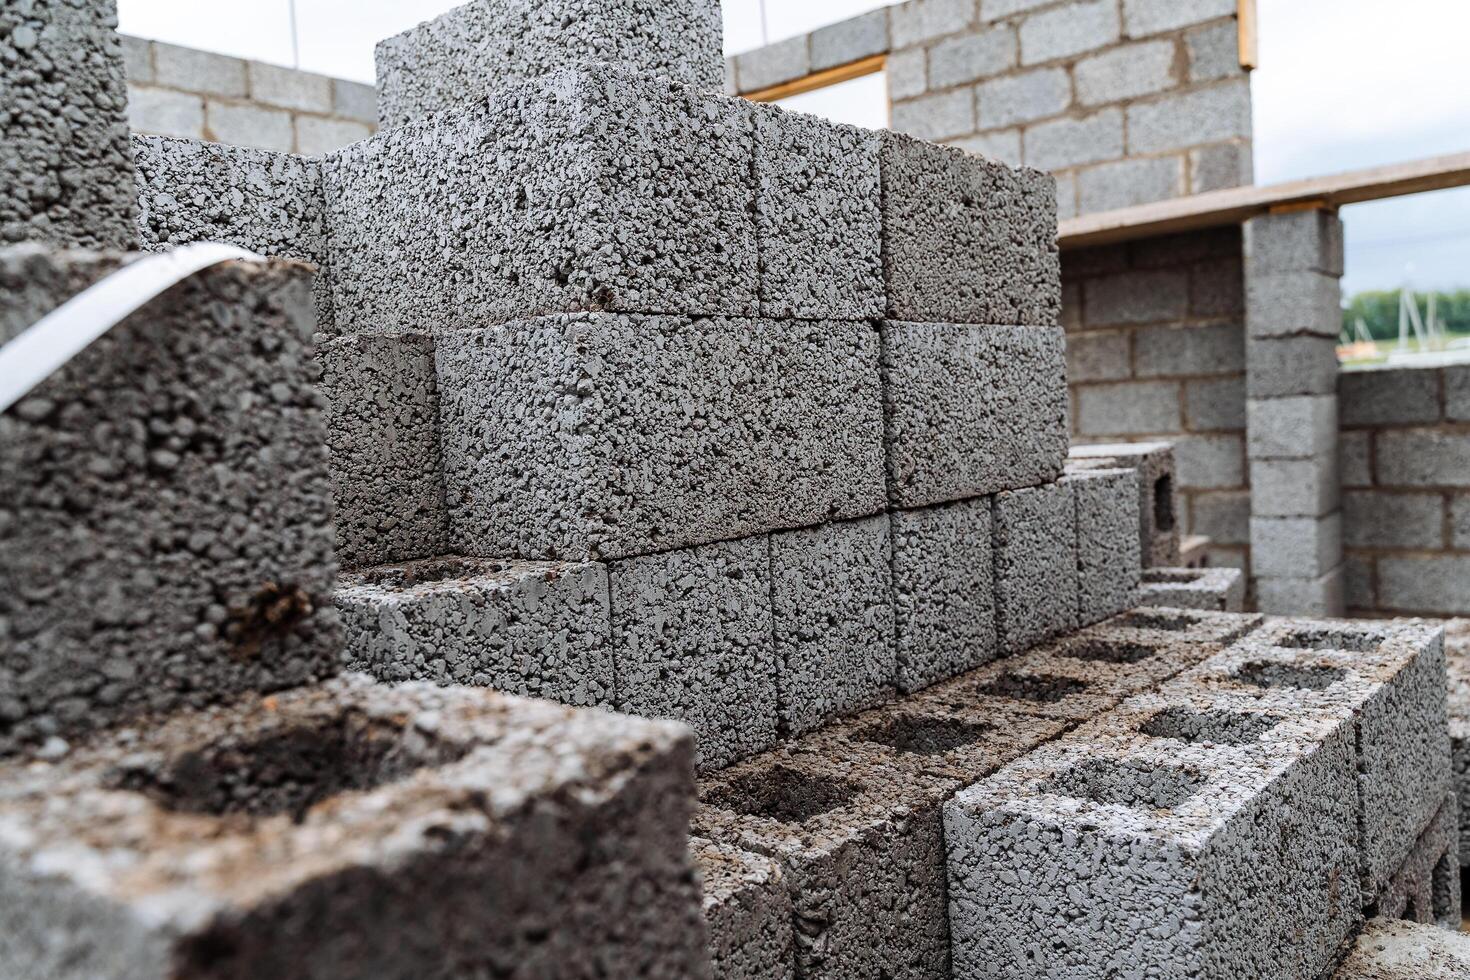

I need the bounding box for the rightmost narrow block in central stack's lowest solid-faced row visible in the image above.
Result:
[1063,470,1141,626]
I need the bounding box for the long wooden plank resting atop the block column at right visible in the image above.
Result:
[1057,153,1470,248]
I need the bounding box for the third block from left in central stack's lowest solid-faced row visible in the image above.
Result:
[770,514,898,735]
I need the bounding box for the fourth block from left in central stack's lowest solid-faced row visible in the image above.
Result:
[889,498,1000,692]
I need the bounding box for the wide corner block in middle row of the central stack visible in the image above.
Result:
[437,313,883,560]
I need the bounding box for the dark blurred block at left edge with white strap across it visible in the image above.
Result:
[0,245,341,754]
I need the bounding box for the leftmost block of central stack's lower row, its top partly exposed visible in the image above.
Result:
[335,557,614,708]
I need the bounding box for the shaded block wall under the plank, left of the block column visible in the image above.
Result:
[1061,229,1251,569]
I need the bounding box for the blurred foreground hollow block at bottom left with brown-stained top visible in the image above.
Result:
[0,677,709,980]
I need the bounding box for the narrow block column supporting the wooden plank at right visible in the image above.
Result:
[1245,209,1344,616]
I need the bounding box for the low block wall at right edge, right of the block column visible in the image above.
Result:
[1338,366,1470,616]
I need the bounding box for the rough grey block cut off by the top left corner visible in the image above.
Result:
[0,0,134,248]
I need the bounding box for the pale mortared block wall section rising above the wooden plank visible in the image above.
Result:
[728,0,1252,219]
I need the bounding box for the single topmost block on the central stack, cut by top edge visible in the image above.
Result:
[378,0,725,128]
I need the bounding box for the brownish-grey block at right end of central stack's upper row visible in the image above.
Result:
[882,134,1061,326]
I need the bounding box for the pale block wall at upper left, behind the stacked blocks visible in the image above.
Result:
[122,35,378,156]
